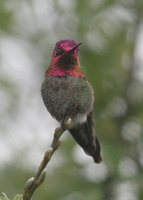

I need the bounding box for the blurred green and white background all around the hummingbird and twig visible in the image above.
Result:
[0,0,143,200]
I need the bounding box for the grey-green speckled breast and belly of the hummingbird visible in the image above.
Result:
[41,76,94,122]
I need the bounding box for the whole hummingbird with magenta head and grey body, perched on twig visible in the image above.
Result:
[41,39,102,163]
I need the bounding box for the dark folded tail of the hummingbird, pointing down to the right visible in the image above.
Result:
[69,113,102,163]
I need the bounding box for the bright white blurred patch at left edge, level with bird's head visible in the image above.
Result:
[0,37,36,88]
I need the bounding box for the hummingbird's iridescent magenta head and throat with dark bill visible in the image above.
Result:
[45,39,84,77]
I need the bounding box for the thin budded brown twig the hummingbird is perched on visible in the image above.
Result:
[23,124,68,200]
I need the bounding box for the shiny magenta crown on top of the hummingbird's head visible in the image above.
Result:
[54,39,79,53]
